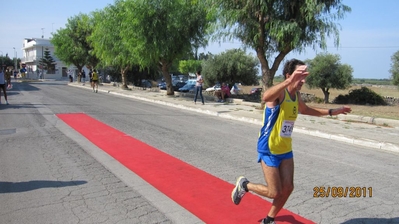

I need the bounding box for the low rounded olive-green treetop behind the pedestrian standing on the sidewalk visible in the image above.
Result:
[202,49,259,86]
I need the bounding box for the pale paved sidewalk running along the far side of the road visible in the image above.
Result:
[69,82,399,152]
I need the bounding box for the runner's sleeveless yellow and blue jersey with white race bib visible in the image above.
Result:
[258,89,298,155]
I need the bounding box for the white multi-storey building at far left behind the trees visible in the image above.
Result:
[21,38,77,80]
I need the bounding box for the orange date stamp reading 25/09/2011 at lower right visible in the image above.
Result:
[313,186,373,198]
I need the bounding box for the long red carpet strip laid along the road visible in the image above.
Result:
[57,114,314,224]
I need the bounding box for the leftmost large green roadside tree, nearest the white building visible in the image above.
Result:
[51,14,98,81]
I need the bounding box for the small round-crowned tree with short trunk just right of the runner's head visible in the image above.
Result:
[306,54,353,103]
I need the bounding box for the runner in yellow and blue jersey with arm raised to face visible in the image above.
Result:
[231,59,351,224]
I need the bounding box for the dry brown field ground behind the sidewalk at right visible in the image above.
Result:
[240,86,399,120]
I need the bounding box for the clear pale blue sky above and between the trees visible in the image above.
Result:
[0,0,399,79]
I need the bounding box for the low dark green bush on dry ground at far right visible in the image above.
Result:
[333,87,387,105]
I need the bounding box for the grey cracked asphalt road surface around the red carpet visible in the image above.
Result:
[0,82,399,224]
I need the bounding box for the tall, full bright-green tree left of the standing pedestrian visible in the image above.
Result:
[119,0,210,95]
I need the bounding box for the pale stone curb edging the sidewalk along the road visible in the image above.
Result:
[69,85,399,153]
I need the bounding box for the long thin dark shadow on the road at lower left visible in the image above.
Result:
[0,180,87,194]
